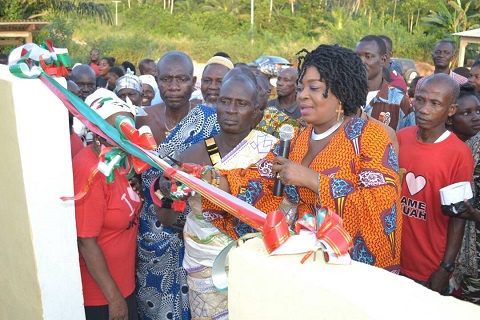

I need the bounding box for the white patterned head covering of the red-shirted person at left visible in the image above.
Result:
[85,88,136,119]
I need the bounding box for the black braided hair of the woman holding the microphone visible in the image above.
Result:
[297,44,368,116]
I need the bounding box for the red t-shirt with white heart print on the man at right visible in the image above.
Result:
[397,126,473,281]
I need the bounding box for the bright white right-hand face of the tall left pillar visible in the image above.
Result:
[0,65,85,320]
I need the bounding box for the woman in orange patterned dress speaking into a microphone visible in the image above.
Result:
[203,45,402,273]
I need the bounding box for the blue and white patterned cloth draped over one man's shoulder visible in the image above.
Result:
[137,105,219,320]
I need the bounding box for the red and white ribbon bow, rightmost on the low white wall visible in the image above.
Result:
[295,208,353,263]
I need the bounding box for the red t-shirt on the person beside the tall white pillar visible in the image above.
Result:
[73,147,142,306]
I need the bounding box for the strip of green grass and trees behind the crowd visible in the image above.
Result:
[0,0,480,63]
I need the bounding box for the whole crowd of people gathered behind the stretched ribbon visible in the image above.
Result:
[3,35,480,320]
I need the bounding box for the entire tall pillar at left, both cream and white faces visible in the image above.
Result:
[0,65,85,320]
